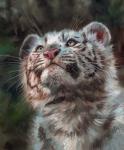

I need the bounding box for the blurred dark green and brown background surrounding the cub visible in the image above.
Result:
[0,0,124,150]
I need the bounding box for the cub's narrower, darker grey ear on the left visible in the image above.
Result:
[19,34,40,59]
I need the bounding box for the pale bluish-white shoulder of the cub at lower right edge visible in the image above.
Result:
[103,90,124,150]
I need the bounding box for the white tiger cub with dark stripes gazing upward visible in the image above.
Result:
[20,22,124,150]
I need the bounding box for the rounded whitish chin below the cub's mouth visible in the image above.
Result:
[41,65,75,92]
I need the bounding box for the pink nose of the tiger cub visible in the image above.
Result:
[43,48,60,60]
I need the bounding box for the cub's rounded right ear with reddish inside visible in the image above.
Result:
[82,22,111,46]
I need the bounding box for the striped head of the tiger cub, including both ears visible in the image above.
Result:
[20,22,111,107]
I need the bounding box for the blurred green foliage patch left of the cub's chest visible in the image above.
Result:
[0,91,33,134]
